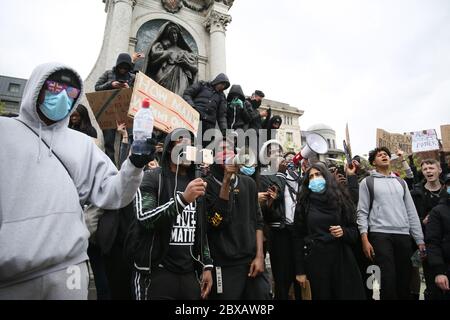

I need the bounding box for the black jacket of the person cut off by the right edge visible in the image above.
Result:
[425,195,450,275]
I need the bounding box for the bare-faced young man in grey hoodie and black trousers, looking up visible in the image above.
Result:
[357,147,425,300]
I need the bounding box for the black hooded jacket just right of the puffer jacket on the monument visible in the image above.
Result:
[227,84,250,131]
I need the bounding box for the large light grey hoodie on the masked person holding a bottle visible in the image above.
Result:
[0,63,143,287]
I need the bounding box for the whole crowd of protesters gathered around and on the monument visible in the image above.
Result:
[0,54,450,300]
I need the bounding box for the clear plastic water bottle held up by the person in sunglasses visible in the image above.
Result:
[131,99,153,154]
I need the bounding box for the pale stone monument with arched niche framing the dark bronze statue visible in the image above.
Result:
[85,0,233,92]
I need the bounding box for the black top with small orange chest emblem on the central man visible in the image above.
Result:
[206,168,264,266]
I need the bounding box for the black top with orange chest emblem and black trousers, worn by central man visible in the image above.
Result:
[205,170,269,300]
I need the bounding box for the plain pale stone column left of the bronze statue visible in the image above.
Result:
[106,0,136,69]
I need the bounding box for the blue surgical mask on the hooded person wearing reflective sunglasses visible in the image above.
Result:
[39,90,73,121]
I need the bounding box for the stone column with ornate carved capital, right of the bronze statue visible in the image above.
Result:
[204,10,231,80]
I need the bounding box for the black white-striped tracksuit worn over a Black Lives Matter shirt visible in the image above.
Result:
[125,129,213,300]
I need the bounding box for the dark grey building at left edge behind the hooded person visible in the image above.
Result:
[0,75,27,114]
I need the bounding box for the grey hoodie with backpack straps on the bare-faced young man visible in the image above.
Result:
[357,171,424,244]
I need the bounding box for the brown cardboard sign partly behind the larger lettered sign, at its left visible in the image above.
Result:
[86,89,133,129]
